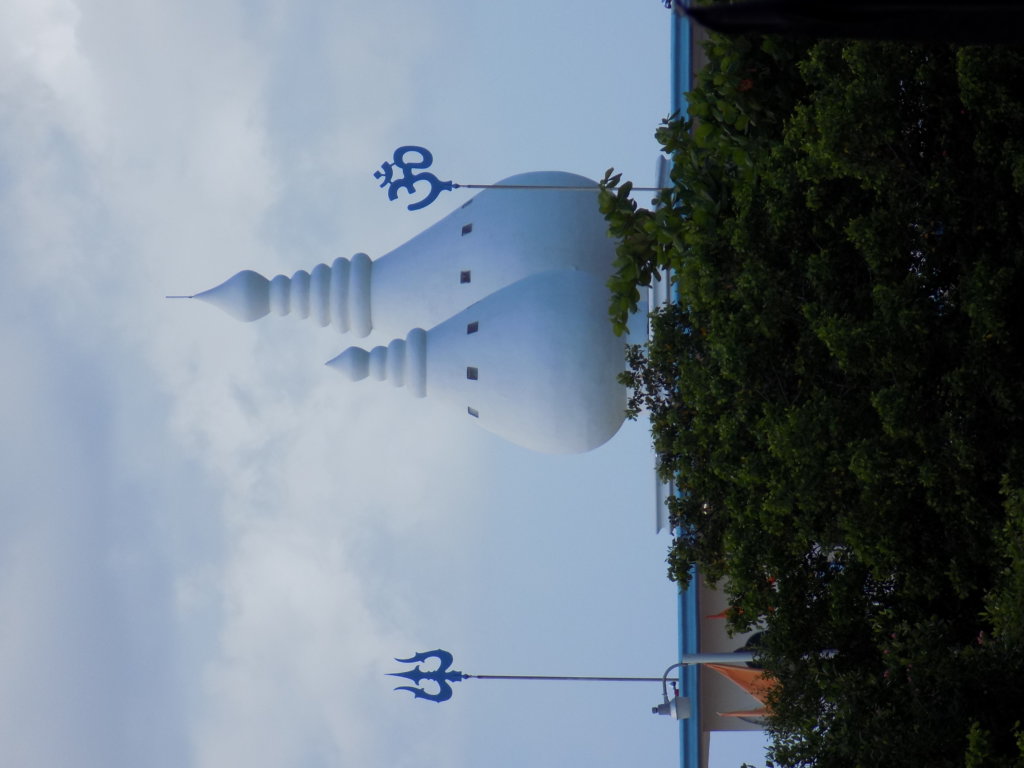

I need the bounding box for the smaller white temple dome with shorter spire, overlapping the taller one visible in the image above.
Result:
[328,270,626,454]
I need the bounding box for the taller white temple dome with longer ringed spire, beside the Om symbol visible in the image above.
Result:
[196,171,615,337]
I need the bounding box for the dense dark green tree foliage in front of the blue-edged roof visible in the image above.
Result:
[601,30,1024,768]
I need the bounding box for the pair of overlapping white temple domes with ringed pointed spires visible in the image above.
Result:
[183,171,630,454]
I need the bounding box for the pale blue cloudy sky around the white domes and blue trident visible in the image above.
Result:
[0,0,761,768]
